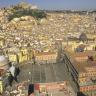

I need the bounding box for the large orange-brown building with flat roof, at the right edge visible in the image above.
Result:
[67,51,96,96]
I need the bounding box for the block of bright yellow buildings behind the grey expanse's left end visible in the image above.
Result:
[6,47,33,63]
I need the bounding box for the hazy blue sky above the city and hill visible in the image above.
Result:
[0,0,96,10]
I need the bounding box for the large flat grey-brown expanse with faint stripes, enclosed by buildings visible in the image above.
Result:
[19,63,68,83]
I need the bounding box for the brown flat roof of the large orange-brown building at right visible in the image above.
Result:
[66,51,96,72]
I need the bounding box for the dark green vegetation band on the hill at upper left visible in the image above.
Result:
[8,3,46,21]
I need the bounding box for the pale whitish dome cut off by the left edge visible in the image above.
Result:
[0,55,8,70]
